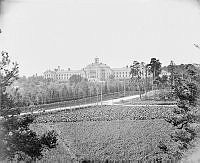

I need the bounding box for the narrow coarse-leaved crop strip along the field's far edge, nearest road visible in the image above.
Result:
[33,105,175,123]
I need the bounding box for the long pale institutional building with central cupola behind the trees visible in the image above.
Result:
[44,58,145,82]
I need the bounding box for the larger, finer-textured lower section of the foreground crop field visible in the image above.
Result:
[33,120,171,161]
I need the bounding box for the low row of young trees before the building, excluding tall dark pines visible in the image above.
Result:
[7,71,150,106]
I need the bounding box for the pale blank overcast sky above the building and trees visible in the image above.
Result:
[0,0,200,76]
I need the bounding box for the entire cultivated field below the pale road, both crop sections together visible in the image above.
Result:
[32,106,178,162]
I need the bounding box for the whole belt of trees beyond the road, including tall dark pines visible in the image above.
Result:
[7,58,200,106]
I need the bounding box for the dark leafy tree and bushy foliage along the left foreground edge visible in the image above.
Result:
[0,52,57,162]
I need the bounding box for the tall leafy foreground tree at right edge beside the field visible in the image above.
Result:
[158,66,199,159]
